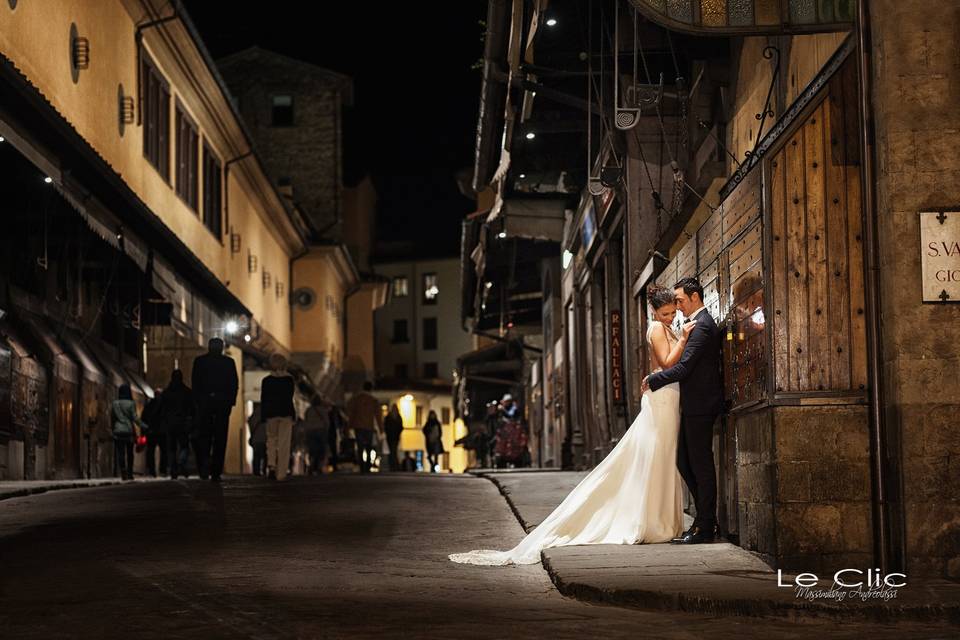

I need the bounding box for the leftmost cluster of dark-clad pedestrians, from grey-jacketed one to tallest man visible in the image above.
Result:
[111,338,239,482]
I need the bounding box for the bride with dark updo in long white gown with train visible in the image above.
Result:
[449,287,695,565]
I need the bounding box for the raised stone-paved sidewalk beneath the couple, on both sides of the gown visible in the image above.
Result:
[476,471,960,625]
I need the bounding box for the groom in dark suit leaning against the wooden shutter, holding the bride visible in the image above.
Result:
[643,278,723,544]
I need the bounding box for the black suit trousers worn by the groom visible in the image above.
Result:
[677,415,717,532]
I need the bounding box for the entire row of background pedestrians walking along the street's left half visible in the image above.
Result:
[112,338,454,482]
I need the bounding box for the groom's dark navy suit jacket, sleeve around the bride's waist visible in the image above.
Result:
[647,309,723,415]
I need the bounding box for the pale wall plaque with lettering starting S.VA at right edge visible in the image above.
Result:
[920,211,960,302]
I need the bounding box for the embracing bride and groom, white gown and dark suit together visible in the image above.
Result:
[449,278,723,565]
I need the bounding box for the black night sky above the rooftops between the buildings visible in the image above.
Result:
[178,0,487,256]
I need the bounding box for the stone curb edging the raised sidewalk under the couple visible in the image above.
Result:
[473,472,960,625]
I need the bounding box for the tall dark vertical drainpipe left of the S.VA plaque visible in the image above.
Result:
[857,0,904,573]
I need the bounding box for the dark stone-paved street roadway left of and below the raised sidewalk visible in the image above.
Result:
[0,474,949,640]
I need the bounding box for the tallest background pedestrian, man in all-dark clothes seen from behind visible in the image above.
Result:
[190,338,240,482]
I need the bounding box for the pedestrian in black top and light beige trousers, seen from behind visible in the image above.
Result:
[260,353,297,481]
